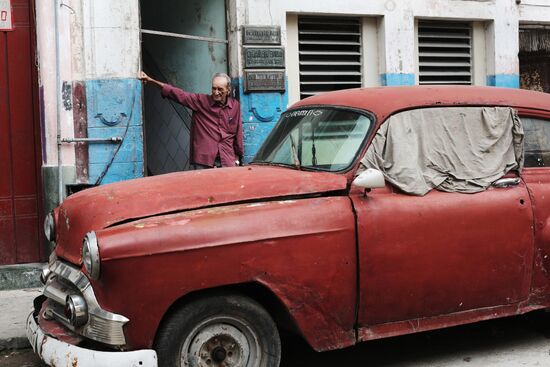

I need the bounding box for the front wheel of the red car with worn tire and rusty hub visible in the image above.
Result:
[155,295,281,367]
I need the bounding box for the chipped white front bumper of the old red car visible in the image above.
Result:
[26,312,157,367]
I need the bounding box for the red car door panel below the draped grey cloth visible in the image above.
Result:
[350,106,534,340]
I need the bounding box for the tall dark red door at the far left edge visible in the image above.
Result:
[0,0,45,265]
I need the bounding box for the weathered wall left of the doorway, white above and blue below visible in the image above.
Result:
[36,0,143,209]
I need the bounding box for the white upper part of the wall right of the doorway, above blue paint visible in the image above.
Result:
[230,0,550,103]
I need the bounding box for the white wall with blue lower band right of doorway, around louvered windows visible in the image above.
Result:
[228,0,550,159]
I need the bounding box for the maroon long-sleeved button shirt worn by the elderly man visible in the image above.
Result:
[162,84,244,167]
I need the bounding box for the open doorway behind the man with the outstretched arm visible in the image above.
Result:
[140,0,228,175]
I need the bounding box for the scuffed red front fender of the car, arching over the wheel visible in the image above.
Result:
[92,196,357,350]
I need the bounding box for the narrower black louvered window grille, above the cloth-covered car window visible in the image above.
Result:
[418,21,472,84]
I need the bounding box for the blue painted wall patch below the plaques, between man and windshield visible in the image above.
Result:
[233,78,288,163]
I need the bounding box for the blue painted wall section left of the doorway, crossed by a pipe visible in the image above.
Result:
[86,79,144,184]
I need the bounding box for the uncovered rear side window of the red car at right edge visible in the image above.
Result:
[521,117,550,167]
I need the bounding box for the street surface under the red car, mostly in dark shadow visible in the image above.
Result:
[0,312,550,367]
